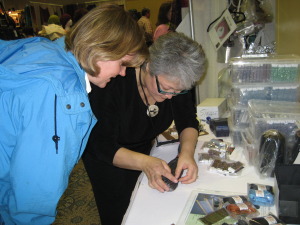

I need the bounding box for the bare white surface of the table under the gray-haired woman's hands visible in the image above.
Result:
[122,126,274,225]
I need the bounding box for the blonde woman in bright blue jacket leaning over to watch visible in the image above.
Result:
[0,5,148,225]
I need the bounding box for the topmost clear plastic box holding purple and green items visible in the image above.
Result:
[229,55,300,83]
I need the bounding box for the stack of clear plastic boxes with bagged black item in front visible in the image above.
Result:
[227,55,300,177]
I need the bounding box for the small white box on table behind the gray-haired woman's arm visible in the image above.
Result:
[197,98,227,120]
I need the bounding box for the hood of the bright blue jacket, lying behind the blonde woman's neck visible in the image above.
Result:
[0,37,85,96]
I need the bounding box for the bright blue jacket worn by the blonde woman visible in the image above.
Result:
[0,38,96,225]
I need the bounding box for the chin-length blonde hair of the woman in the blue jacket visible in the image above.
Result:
[65,4,149,76]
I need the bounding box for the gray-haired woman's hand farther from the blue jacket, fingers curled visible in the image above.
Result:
[175,153,198,184]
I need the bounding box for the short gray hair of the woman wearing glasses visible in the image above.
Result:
[147,32,206,90]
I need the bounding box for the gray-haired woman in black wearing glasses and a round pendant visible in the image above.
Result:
[83,32,206,225]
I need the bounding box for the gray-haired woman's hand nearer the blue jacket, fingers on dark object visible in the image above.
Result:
[142,156,178,192]
